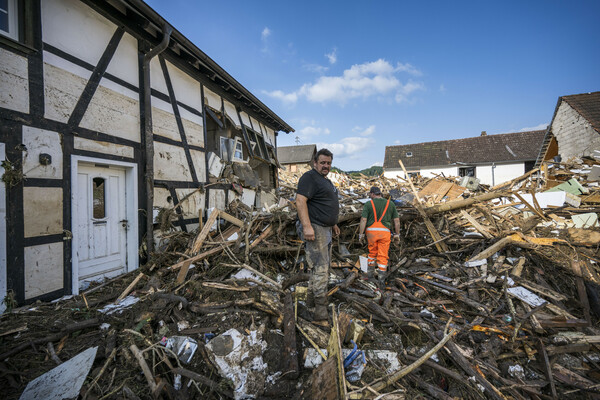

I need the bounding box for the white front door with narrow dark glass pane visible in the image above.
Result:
[74,163,128,289]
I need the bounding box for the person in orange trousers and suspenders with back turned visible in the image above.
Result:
[358,186,400,283]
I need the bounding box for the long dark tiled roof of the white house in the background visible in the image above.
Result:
[383,131,546,169]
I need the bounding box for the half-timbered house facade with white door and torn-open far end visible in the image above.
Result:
[0,0,293,303]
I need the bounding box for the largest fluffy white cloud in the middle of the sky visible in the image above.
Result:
[267,59,425,104]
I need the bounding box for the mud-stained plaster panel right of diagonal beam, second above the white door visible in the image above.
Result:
[79,78,141,143]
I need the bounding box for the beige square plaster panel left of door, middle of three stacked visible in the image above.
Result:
[23,187,63,237]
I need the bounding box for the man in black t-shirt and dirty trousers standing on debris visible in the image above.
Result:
[296,149,340,321]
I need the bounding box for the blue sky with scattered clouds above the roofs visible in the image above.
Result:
[147,0,600,170]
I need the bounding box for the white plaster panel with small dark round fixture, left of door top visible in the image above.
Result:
[23,126,63,179]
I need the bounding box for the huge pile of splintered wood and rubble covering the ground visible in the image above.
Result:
[0,159,600,399]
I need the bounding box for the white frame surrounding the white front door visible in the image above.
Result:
[71,155,139,295]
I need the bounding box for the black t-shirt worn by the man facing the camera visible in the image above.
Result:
[296,169,340,226]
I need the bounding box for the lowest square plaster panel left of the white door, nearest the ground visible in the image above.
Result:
[25,243,63,299]
